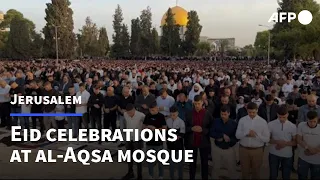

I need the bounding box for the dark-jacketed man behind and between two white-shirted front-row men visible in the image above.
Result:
[258,94,279,122]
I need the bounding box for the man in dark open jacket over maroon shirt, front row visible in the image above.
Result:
[185,95,213,180]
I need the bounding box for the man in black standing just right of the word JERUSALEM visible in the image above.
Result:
[88,84,104,144]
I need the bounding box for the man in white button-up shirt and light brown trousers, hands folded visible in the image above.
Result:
[236,102,270,179]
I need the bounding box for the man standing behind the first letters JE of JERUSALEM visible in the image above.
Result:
[9,81,24,126]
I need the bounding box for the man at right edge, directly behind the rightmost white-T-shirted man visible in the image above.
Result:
[298,95,320,123]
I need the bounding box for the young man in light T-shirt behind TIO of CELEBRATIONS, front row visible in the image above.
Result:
[122,103,145,179]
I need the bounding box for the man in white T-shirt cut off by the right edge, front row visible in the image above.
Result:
[297,111,320,179]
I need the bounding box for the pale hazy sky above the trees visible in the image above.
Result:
[0,0,320,46]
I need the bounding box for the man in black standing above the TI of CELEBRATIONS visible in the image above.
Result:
[118,86,134,147]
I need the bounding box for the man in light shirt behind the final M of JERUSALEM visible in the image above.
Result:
[76,83,90,129]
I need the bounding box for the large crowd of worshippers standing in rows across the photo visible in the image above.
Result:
[0,61,320,179]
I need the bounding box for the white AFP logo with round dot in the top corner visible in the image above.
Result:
[268,10,313,25]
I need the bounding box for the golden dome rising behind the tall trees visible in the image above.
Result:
[161,6,188,26]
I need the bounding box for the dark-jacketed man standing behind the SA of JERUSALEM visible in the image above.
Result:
[43,82,58,131]
